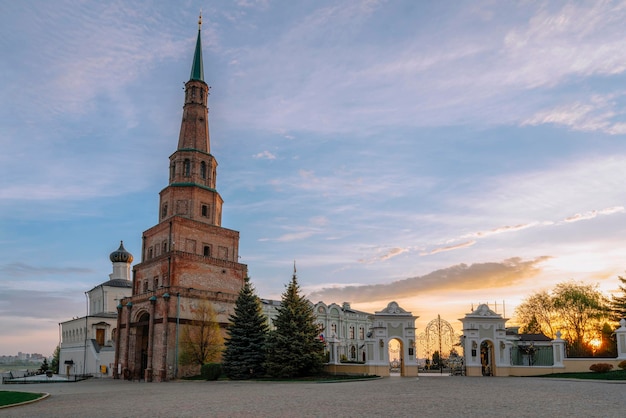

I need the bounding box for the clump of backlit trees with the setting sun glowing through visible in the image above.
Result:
[515,281,612,357]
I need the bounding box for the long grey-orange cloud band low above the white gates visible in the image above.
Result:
[310,256,550,303]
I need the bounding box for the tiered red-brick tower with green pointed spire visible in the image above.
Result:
[114,16,247,381]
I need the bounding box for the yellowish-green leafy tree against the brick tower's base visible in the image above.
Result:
[180,302,223,366]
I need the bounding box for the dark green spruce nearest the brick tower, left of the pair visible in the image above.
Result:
[222,277,268,379]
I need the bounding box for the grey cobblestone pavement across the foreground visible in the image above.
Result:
[0,376,626,418]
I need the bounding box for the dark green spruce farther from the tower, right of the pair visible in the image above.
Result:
[265,267,324,377]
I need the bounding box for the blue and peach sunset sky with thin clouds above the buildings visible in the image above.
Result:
[0,0,626,355]
